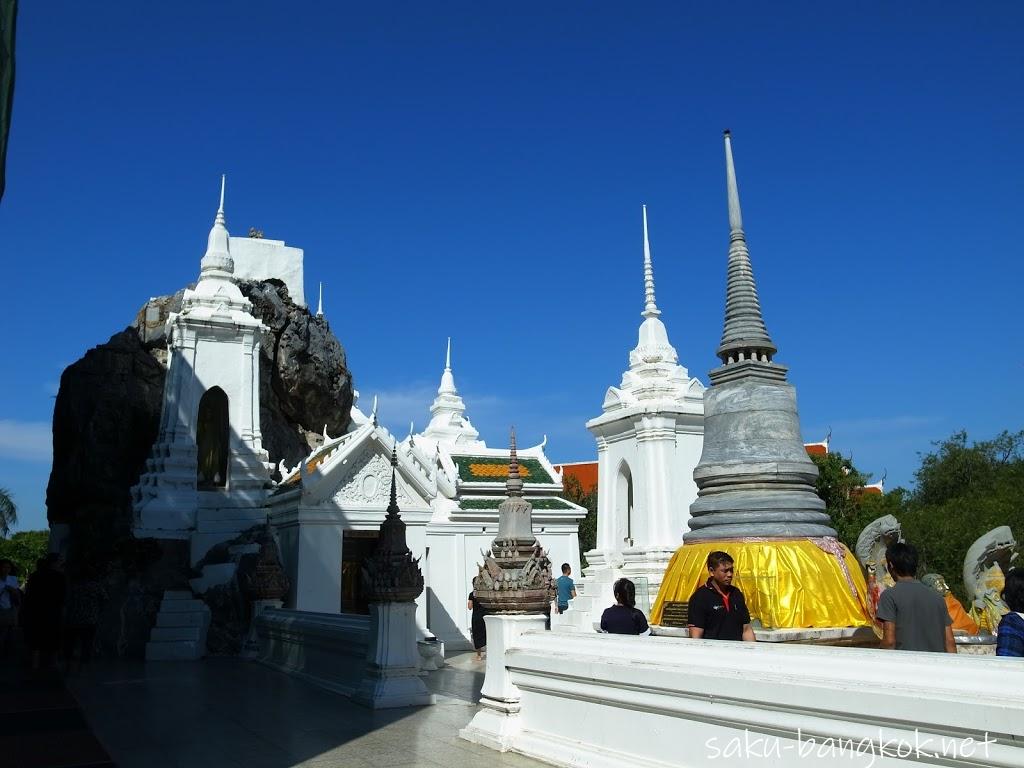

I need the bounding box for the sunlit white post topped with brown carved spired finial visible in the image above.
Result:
[459,430,554,752]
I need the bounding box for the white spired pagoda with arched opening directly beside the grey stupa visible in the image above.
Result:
[554,206,705,629]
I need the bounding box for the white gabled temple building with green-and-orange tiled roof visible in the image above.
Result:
[268,343,587,648]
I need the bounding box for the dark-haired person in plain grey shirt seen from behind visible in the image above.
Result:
[876,543,956,653]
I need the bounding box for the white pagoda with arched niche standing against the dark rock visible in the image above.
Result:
[132,177,270,562]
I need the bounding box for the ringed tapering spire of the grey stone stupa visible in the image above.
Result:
[716,131,776,366]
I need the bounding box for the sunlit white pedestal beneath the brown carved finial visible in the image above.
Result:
[459,613,544,752]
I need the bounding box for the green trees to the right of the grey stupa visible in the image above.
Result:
[814,430,1024,600]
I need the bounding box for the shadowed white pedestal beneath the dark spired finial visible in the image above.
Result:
[352,602,434,710]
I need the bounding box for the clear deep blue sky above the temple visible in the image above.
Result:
[0,0,1024,528]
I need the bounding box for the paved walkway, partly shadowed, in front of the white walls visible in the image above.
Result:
[58,653,542,768]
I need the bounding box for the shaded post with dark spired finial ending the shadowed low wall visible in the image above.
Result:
[352,450,434,710]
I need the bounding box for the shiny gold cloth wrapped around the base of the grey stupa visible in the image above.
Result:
[650,539,871,629]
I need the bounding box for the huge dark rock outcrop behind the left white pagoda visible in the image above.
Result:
[46,280,352,655]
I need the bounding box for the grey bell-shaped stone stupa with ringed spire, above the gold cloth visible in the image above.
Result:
[683,131,836,544]
